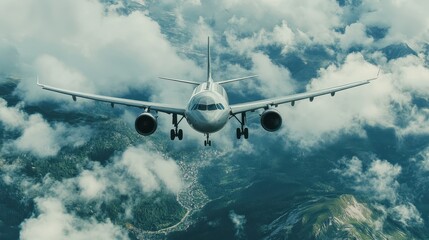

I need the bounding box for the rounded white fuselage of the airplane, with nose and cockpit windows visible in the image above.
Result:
[185,81,230,134]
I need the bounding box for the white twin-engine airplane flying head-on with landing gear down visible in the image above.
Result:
[37,38,378,146]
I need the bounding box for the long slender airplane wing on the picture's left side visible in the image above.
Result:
[37,80,185,115]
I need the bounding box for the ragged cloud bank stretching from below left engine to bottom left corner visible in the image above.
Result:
[2,145,185,239]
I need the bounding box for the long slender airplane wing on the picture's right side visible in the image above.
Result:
[230,76,378,115]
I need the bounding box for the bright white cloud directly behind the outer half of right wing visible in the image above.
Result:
[280,54,382,148]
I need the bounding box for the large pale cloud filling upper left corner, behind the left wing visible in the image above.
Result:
[0,0,204,106]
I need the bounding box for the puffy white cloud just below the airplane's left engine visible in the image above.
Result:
[73,145,186,202]
